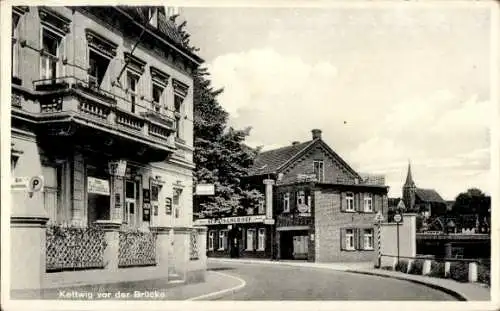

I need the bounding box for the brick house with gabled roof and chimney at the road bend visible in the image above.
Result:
[197,129,388,262]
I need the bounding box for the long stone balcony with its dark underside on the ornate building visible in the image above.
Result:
[12,77,176,161]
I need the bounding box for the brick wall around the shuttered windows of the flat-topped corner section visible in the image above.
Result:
[314,189,388,262]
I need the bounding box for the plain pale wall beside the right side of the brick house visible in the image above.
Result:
[376,214,417,267]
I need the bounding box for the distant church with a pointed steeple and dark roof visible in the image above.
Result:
[403,164,447,218]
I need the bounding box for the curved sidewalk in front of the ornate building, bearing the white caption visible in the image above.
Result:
[11,271,245,301]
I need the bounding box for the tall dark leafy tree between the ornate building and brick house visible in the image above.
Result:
[170,15,262,217]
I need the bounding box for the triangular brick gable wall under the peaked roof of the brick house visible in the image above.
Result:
[277,143,354,184]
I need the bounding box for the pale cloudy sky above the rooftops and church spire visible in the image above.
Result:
[181,6,493,200]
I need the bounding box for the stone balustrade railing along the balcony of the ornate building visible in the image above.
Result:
[25,76,175,144]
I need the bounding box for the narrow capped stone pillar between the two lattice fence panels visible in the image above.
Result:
[95,220,121,272]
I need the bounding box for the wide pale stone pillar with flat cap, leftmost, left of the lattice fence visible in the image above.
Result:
[10,216,48,298]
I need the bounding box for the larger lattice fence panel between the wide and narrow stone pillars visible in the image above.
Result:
[45,226,106,271]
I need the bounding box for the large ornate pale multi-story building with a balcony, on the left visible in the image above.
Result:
[11,6,204,296]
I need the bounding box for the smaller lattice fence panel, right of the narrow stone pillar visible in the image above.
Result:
[118,231,156,267]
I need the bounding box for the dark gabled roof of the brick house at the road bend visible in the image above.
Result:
[249,138,362,180]
